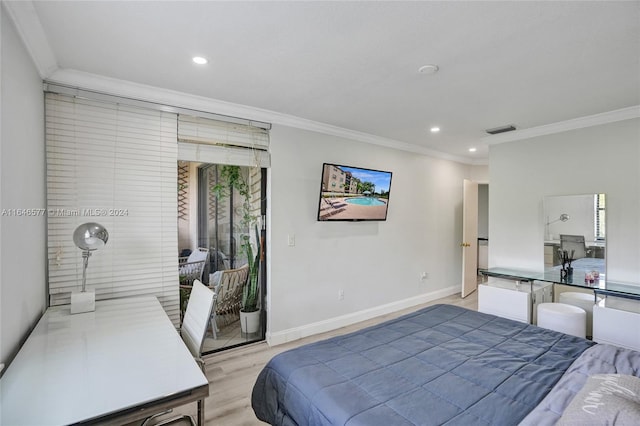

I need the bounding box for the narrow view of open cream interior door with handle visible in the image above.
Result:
[460,179,478,297]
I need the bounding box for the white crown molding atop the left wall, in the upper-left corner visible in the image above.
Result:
[2,1,58,80]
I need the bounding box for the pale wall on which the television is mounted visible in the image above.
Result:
[269,126,471,343]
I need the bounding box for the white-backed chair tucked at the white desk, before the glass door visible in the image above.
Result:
[142,279,215,426]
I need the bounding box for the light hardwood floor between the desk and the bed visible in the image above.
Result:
[162,291,478,426]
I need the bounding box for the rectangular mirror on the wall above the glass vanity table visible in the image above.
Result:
[543,194,606,274]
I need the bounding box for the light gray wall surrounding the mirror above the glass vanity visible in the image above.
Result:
[489,119,640,285]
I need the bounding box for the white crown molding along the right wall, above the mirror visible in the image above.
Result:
[481,105,640,145]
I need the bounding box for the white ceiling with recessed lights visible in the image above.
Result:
[7,1,640,163]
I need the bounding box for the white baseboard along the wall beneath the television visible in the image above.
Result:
[266,285,460,346]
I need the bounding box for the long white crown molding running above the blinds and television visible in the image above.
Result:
[47,69,476,165]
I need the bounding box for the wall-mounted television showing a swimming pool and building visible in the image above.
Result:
[318,163,391,222]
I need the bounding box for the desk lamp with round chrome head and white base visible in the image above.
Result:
[71,222,109,314]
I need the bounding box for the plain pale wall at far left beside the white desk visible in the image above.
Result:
[0,6,47,362]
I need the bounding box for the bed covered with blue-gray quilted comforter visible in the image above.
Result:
[252,305,640,426]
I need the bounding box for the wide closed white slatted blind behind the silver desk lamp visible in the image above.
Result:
[46,93,179,323]
